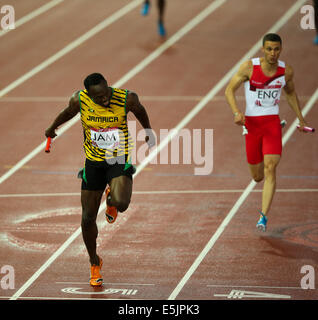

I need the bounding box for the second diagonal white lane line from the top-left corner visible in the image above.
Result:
[0,0,143,98]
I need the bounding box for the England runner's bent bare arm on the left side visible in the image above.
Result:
[225,61,252,125]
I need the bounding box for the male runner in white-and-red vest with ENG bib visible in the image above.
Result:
[225,33,307,231]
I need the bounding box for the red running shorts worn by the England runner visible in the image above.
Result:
[245,115,282,164]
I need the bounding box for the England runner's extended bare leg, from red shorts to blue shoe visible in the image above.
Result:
[262,154,280,215]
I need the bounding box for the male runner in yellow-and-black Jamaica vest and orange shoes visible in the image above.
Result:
[45,73,155,286]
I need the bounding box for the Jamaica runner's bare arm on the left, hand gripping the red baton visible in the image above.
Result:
[45,92,80,138]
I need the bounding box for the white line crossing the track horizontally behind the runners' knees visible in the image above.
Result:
[0,188,318,198]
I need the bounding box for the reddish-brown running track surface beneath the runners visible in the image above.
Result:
[0,0,318,300]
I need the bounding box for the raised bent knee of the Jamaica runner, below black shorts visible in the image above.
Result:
[107,176,133,212]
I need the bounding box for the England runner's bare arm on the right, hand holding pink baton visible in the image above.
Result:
[284,65,307,131]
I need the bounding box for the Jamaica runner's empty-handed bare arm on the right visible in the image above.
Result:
[126,91,156,148]
